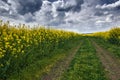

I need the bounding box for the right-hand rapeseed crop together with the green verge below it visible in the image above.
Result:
[89,27,120,59]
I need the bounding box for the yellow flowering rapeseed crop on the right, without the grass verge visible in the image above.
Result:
[91,27,120,46]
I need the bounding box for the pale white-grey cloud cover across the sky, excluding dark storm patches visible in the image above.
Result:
[0,0,120,32]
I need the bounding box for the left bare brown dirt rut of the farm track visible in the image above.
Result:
[42,45,80,80]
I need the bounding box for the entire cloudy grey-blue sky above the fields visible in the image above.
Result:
[0,0,120,33]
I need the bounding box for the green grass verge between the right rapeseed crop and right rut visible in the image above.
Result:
[92,38,120,61]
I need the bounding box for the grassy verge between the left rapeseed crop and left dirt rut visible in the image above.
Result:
[8,40,80,80]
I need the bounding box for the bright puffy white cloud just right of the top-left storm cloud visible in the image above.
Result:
[34,0,52,25]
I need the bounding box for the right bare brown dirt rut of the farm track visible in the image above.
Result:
[92,41,120,80]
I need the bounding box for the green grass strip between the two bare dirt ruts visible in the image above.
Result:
[61,38,107,80]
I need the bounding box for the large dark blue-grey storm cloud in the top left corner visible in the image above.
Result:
[0,0,42,15]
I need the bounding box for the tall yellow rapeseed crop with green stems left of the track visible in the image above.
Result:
[0,22,79,79]
